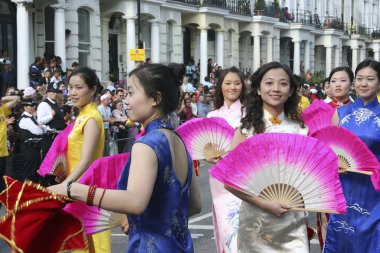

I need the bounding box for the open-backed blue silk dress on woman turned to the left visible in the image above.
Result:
[118,119,194,253]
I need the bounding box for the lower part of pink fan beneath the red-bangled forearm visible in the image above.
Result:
[64,201,127,235]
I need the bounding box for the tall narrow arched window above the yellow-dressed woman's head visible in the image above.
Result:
[78,8,91,66]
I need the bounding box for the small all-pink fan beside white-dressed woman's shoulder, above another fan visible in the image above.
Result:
[302,100,335,135]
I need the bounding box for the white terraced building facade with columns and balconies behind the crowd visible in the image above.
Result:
[4,0,380,89]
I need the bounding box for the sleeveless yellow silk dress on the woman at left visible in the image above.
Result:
[66,103,111,253]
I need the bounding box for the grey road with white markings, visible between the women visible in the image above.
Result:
[0,163,320,253]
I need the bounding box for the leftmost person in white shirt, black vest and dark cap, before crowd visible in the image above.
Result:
[18,98,48,182]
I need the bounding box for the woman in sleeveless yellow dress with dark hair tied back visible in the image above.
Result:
[58,67,111,253]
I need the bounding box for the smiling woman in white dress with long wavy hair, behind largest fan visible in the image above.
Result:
[226,62,309,253]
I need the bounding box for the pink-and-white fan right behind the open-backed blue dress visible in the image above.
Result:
[176,117,234,160]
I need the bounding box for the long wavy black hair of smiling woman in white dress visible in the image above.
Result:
[241,62,303,134]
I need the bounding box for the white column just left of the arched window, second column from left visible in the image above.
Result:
[50,4,66,71]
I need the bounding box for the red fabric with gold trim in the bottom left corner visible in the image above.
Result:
[0,177,88,253]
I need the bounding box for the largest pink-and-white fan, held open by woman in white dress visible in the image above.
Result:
[210,133,346,213]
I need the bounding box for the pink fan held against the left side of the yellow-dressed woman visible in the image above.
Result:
[37,123,74,177]
